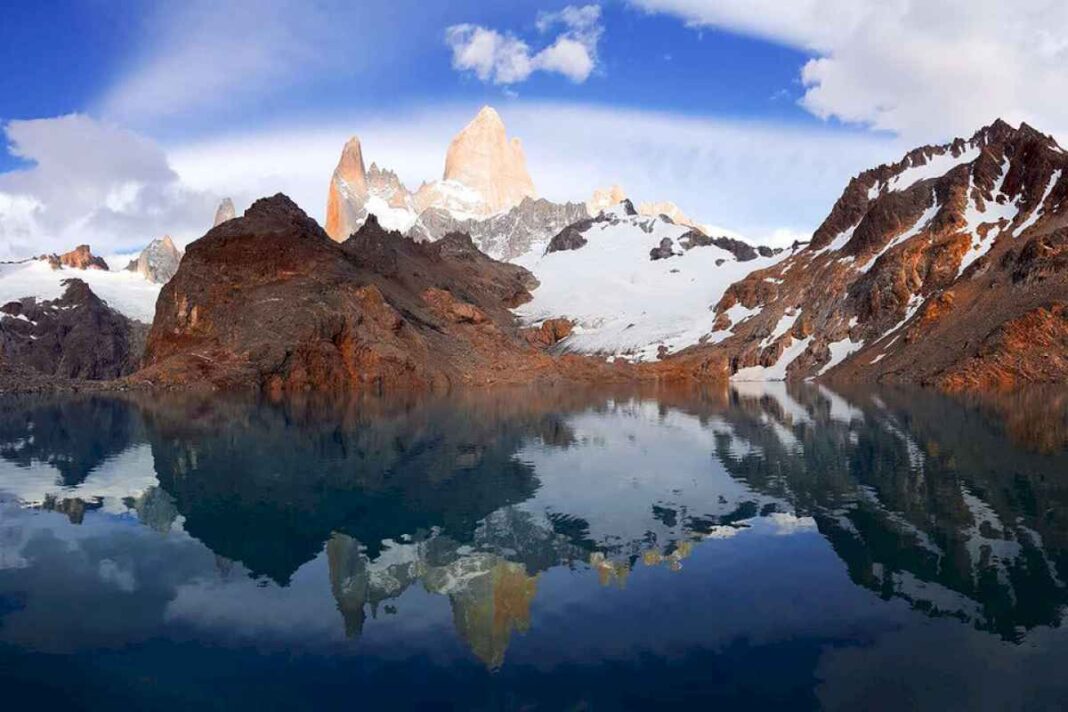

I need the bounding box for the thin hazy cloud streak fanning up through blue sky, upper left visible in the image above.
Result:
[94,0,380,124]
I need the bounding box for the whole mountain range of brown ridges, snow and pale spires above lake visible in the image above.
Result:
[0,107,1068,390]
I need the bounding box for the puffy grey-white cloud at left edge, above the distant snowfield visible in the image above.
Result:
[0,114,216,259]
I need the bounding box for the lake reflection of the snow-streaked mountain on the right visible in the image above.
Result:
[719,384,1068,642]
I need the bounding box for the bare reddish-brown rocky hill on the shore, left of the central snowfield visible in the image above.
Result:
[137,194,645,391]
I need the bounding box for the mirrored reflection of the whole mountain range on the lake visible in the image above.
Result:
[0,384,1068,668]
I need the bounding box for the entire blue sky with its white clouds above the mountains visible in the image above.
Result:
[0,0,1068,254]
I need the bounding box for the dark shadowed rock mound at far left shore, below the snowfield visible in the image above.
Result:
[0,279,147,380]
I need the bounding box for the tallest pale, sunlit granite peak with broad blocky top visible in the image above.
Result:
[442,107,537,215]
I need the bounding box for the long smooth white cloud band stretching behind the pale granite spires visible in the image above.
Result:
[169,101,905,244]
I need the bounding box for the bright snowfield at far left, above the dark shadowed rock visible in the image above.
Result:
[0,259,162,323]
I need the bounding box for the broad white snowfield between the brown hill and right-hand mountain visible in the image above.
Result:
[515,206,781,361]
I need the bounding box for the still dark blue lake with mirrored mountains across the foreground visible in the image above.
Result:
[0,384,1068,710]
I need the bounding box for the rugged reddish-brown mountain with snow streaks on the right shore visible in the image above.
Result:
[700,121,1068,390]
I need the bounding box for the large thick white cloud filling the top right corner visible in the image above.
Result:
[631,0,1068,141]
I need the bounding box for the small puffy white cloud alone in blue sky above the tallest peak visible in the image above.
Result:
[445,5,603,84]
